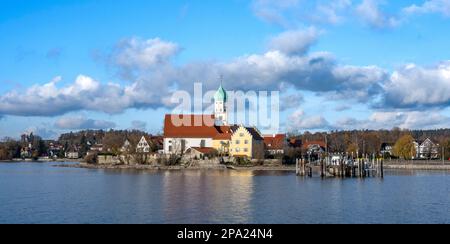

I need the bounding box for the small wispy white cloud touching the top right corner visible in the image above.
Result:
[403,0,450,17]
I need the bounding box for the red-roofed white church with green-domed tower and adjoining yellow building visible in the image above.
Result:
[164,85,264,159]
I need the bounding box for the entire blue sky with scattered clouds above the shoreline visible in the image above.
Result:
[0,0,450,138]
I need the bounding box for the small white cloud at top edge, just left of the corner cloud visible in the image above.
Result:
[356,0,401,28]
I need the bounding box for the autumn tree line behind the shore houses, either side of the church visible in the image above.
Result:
[0,128,450,160]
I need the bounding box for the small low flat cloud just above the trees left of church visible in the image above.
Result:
[55,117,116,130]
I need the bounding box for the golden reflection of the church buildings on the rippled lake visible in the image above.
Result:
[161,171,254,223]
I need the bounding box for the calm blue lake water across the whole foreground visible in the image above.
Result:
[0,163,450,224]
